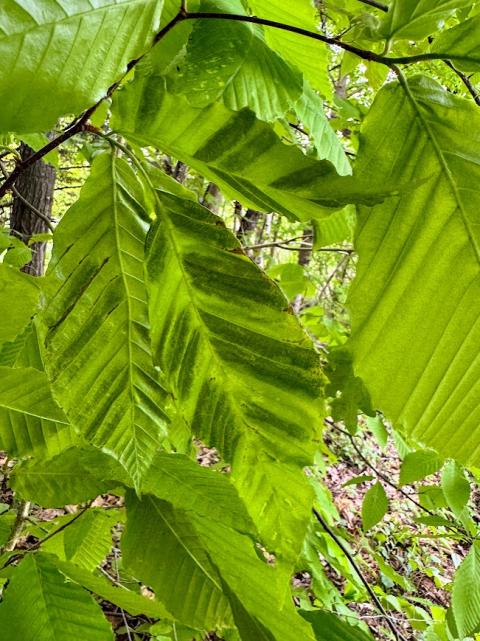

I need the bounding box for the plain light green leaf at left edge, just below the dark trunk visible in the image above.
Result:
[0,264,40,344]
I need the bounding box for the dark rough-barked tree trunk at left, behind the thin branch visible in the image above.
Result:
[10,143,56,276]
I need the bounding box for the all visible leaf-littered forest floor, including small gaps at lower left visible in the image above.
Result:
[0,428,472,641]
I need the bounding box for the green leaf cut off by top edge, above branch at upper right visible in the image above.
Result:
[380,0,472,40]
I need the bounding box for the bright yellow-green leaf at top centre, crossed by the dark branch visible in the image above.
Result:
[248,0,332,99]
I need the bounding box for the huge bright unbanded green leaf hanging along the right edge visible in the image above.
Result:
[349,77,480,465]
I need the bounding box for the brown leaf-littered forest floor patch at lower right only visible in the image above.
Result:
[318,420,468,641]
